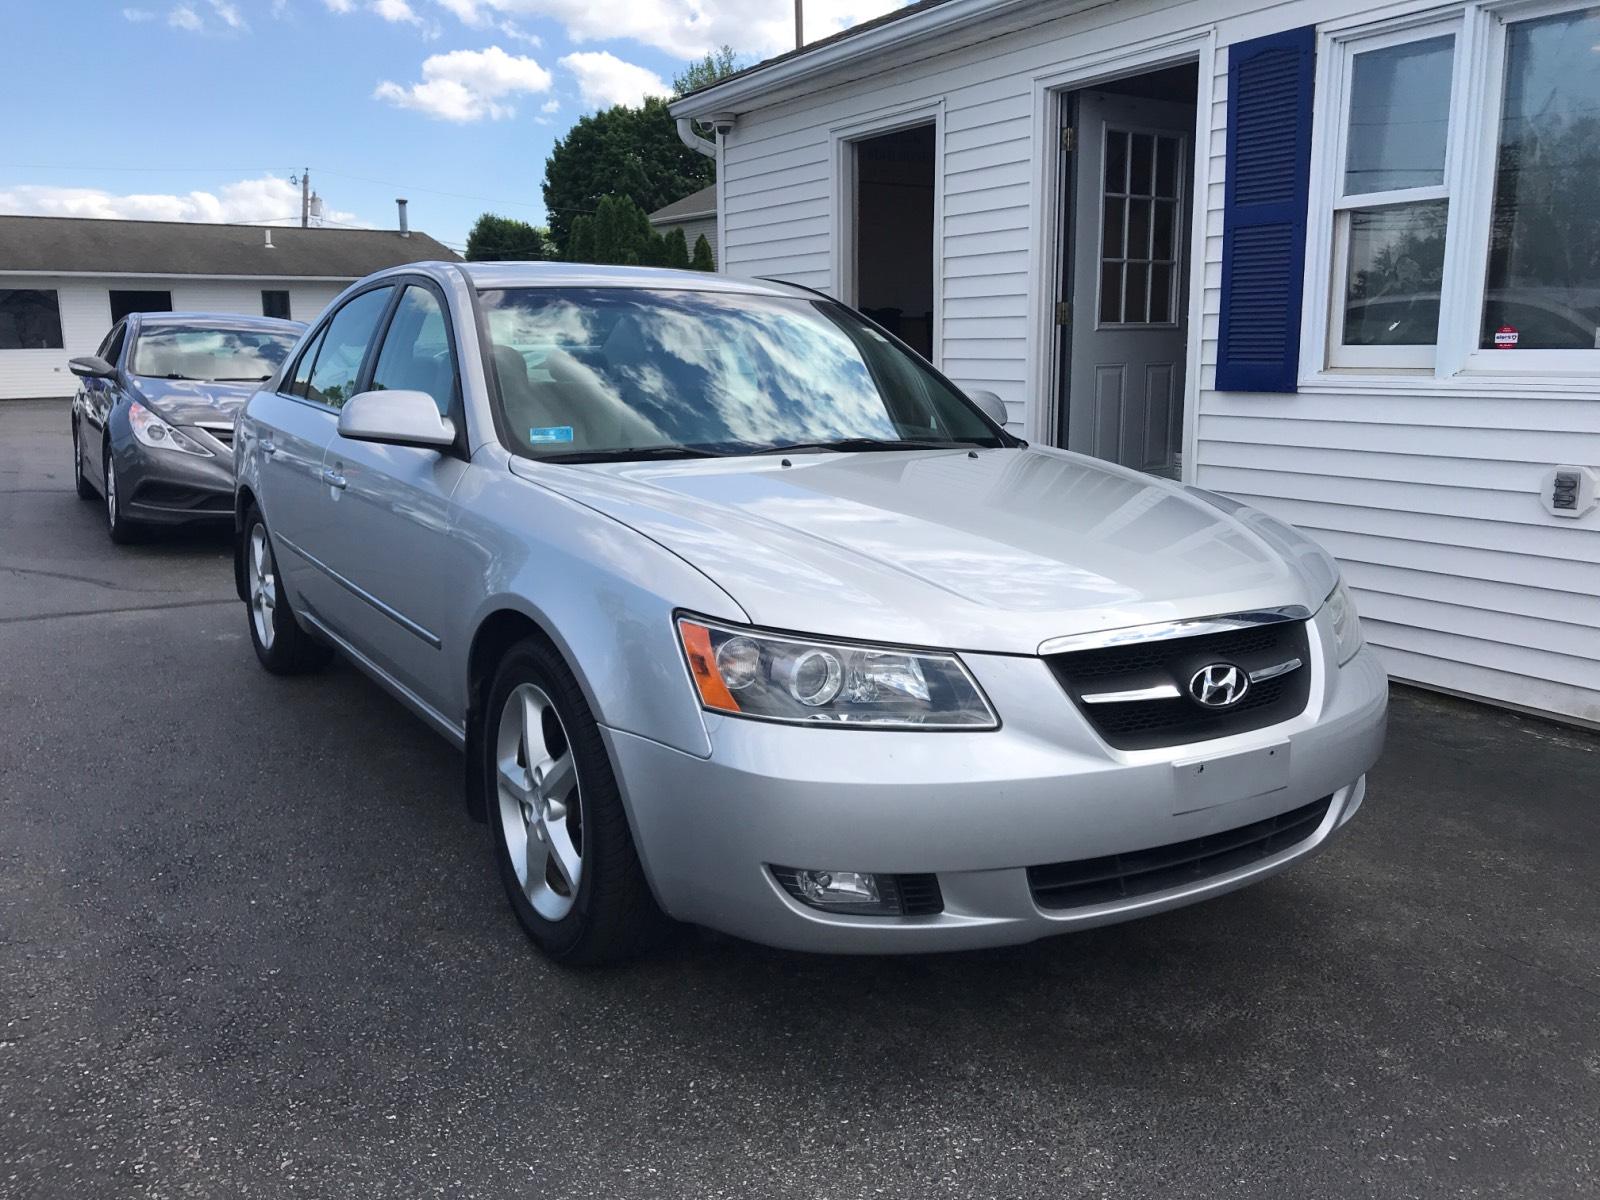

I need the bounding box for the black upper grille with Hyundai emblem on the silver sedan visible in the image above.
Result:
[1045,621,1310,750]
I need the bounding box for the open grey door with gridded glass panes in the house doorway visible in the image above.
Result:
[1067,91,1195,475]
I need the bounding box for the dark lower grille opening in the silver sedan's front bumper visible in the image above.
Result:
[1027,795,1333,909]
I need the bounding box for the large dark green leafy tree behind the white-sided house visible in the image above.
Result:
[544,96,715,258]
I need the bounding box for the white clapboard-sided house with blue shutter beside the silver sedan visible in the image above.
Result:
[672,0,1600,723]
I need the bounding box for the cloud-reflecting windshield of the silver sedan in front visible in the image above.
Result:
[482,288,1008,459]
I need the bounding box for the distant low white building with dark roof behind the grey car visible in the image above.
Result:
[0,216,458,400]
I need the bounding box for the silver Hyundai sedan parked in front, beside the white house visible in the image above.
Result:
[235,262,1387,963]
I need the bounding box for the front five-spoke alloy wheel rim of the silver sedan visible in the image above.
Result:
[494,683,584,922]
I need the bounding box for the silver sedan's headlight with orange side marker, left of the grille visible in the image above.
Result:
[678,618,1000,730]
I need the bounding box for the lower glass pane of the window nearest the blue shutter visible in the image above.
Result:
[1344,200,1450,346]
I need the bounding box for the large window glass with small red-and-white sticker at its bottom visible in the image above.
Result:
[1480,8,1600,350]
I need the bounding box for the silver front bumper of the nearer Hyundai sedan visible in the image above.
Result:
[605,622,1387,954]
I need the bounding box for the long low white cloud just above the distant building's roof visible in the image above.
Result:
[0,176,366,226]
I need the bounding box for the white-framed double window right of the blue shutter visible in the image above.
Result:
[1309,0,1600,376]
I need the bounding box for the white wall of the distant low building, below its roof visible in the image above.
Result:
[0,275,346,400]
